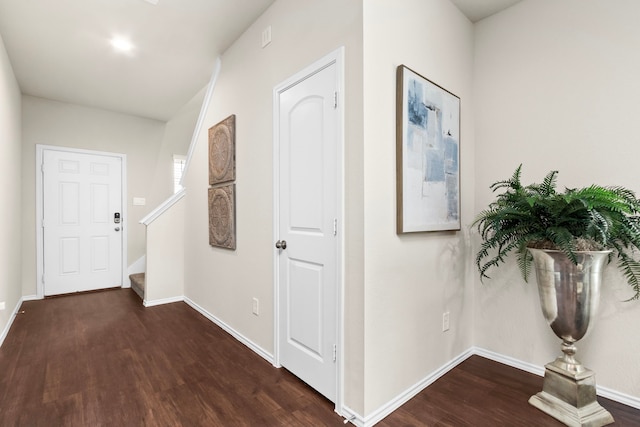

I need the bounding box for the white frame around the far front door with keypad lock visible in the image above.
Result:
[36,144,129,299]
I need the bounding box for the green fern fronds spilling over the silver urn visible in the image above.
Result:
[472,165,640,300]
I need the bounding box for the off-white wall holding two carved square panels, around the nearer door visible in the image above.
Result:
[185,0,364,409]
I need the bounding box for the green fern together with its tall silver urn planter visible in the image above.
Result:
[472,165,640,426]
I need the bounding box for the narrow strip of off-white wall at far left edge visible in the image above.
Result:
[0,32,22,343]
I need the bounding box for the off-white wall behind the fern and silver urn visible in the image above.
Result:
[472,0,640,398]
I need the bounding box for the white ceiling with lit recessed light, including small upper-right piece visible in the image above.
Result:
[0,0,519,120]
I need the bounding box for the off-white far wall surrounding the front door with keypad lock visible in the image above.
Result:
[22,96,168,295]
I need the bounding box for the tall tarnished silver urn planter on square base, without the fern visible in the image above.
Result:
[529,248,613,427]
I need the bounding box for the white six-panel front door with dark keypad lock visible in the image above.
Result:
[42,149,124,296]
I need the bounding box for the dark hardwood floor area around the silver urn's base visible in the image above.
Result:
[378,356,640,427]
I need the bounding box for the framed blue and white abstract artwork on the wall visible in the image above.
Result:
[398,66,460,233]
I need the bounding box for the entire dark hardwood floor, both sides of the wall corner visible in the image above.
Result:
[0,289,640,427]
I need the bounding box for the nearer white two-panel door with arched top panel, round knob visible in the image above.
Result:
[275,51,341,402]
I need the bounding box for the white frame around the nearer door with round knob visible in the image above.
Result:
[273,47,345,413]
